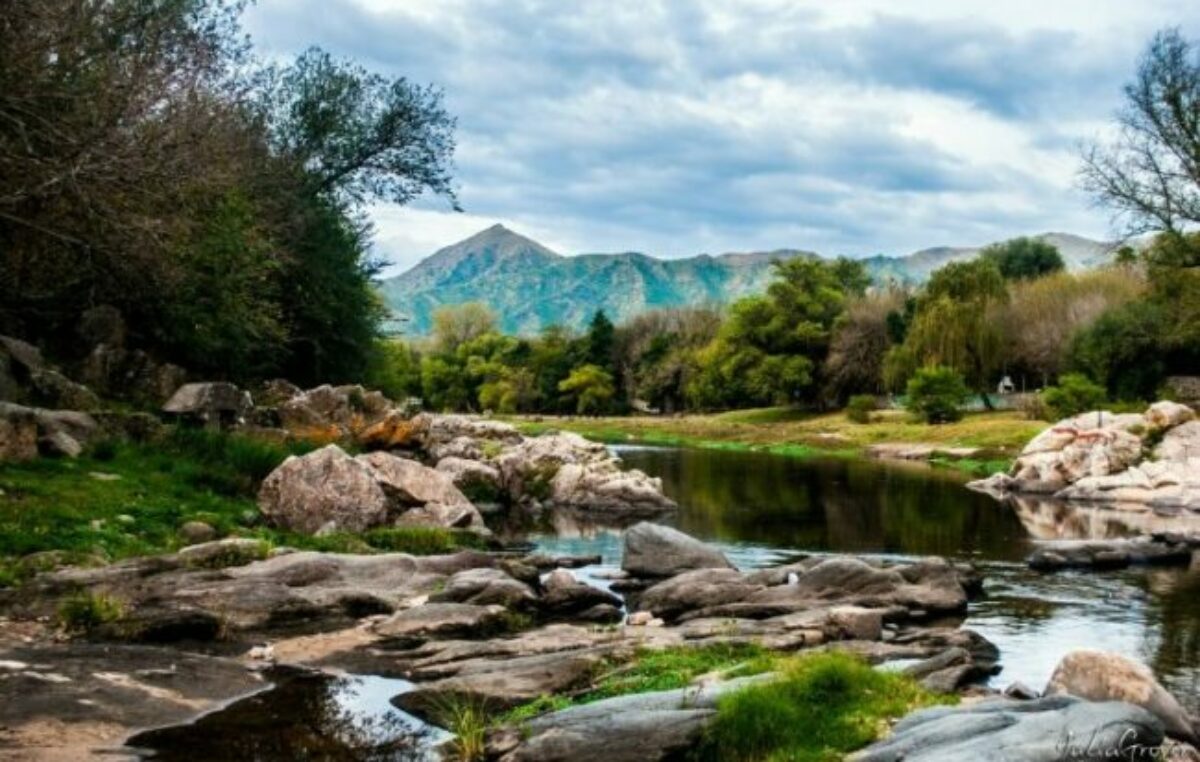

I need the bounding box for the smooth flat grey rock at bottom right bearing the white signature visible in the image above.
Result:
[848,696,1163,762]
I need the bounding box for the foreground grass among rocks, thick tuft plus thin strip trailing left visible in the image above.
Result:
[445,644,955,762]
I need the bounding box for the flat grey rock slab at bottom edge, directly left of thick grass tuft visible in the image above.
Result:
[488,676,769,762]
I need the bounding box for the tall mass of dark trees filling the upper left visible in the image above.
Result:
[0,0,455,384]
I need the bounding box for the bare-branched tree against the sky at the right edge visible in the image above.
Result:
[1082,29,1200,235]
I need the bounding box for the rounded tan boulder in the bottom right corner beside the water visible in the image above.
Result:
[1044,649,1200,743]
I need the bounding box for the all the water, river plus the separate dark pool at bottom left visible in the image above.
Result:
[133,448,1200,762]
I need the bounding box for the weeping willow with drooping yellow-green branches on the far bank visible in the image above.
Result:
[886,258,1008,406]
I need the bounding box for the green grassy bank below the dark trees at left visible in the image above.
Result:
[0,430,479,584]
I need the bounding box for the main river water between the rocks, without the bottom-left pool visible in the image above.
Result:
[539,448,1200,710]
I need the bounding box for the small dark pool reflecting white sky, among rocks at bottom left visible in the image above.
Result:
[128,673,442,762]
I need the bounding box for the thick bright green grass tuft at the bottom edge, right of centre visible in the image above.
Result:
[696,652,954,762]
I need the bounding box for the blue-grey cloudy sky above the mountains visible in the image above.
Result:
[246,0,1200,270]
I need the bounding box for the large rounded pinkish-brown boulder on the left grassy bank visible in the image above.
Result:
[258,444,390,534]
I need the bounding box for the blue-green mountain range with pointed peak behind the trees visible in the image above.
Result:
[380,224,1110,336]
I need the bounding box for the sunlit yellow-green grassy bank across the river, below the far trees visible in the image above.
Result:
[510,408,1046,473]
